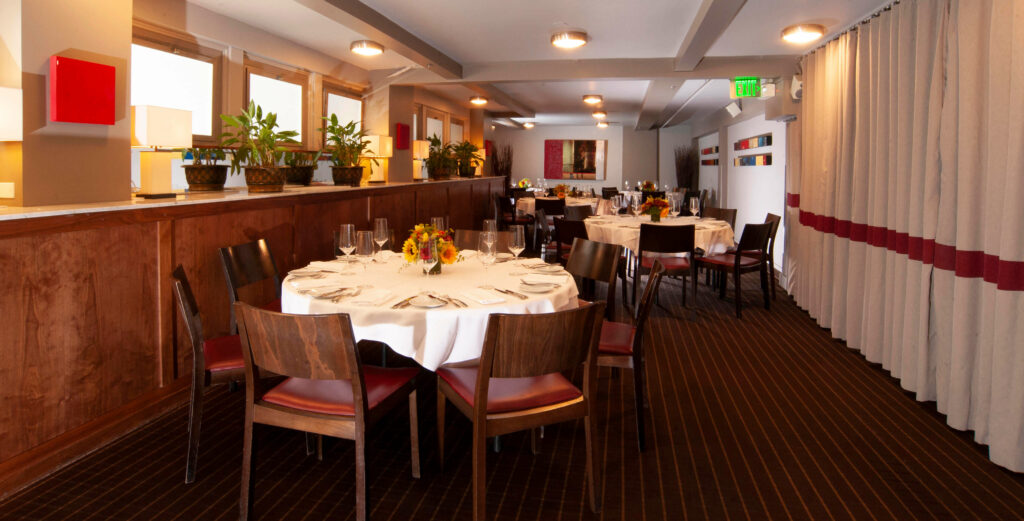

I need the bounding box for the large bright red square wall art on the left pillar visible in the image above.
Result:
[50,56,116,125]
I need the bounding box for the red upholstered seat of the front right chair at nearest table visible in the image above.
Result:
[437,367,583,413]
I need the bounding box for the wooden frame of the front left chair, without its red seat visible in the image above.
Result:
[233,302,420,521]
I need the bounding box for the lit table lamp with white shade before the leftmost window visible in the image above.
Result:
[131,105,191,199]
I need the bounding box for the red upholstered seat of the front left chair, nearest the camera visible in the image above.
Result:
[263,365,420,416]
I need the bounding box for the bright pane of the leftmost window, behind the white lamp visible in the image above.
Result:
[130,43,219,140]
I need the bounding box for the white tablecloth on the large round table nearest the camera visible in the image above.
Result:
[281,251,578,371]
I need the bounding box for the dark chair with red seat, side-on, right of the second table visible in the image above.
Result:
[693,222,773,318]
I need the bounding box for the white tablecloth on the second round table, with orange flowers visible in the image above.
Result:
[585,215,735,255]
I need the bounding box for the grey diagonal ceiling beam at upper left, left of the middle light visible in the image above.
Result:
[296,0,462,80]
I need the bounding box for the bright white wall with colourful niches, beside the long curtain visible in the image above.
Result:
[719,115,785,269]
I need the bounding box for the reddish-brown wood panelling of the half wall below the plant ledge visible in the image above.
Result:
[0,177,504,497]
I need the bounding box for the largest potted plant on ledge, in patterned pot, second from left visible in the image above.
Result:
[220,101,299,191]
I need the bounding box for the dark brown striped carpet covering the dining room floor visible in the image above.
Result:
[0,275,1024,521]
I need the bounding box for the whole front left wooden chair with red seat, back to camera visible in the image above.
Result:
[233,302,420,521]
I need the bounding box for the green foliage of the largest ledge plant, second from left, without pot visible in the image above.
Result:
[220,101,299,174]
